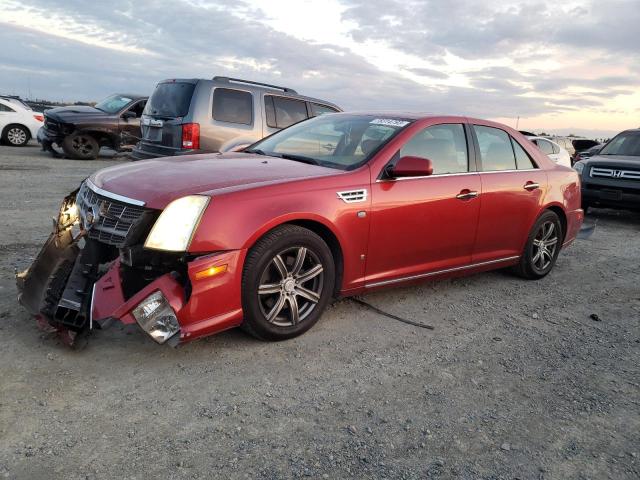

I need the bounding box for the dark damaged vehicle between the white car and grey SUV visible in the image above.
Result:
[38,94,147,160]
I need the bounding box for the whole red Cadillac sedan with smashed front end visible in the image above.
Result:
[18,113,583,345]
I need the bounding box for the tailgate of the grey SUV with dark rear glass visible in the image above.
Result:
[140,81,196,155]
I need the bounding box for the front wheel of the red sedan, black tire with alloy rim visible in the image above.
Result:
[242,225,335,340]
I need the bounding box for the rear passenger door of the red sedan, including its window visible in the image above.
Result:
[472,125,547,263]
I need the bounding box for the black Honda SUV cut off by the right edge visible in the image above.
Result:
[573,129,640,211]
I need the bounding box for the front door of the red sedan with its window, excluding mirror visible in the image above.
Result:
[366,123,480,286]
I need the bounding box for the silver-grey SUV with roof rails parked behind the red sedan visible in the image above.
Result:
[131,77,342,160]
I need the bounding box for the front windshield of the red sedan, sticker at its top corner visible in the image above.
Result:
[246,113,411,170]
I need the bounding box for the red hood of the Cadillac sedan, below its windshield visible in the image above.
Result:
[90,153,342,209]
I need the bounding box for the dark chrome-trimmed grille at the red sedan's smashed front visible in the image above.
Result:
[76,182,145,248]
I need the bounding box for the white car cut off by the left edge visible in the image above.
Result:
[0,96,44,147]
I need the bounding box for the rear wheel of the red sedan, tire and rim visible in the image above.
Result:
[515,210,564,280]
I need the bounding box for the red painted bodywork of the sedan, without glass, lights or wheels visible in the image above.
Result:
[86,117,583,341]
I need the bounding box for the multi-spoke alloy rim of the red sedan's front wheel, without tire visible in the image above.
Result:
[257,247,324,327]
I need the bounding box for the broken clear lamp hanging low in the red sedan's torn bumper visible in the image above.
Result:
[131,292,180,343]
